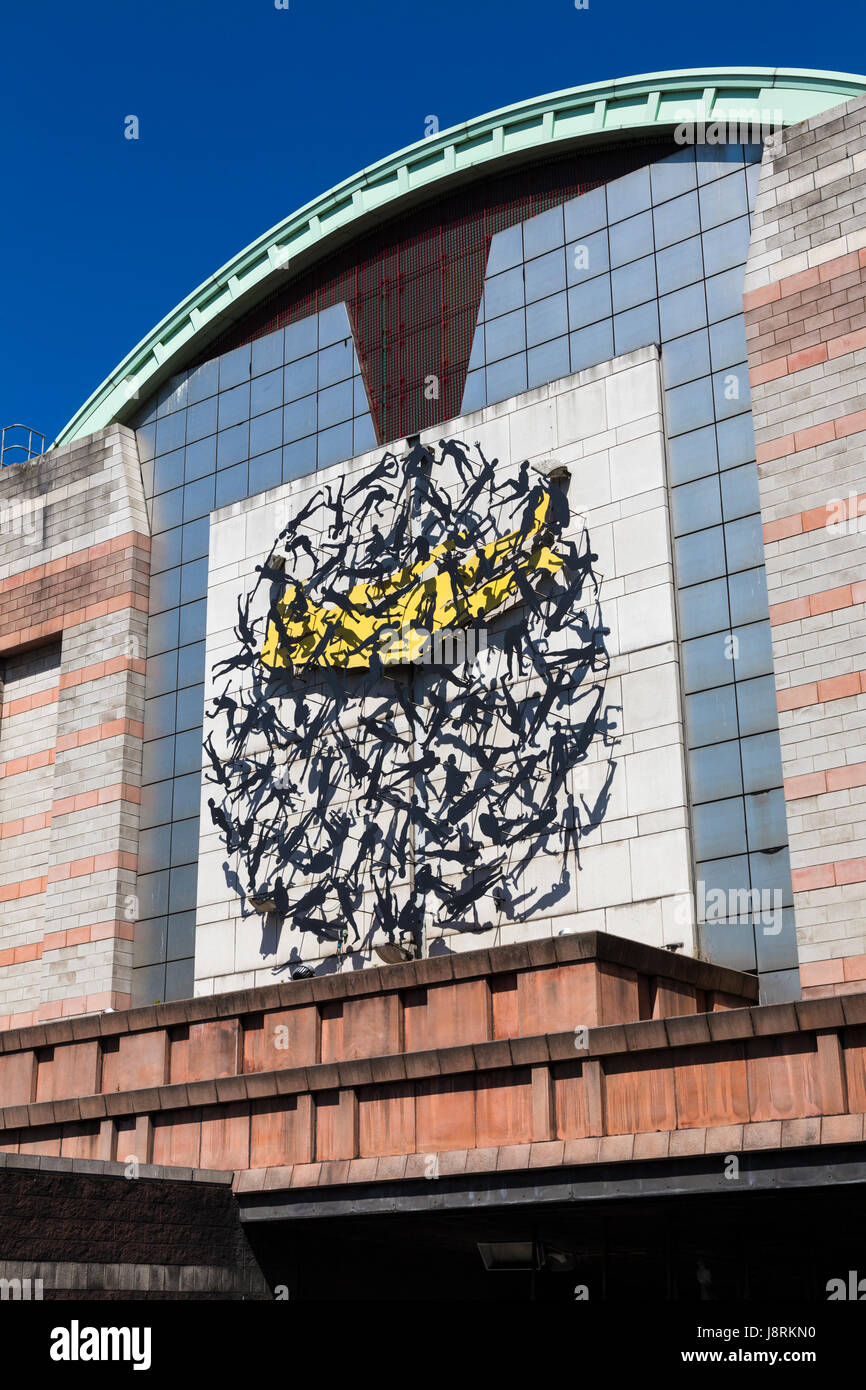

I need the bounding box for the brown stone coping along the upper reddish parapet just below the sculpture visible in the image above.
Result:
[0,931,759,1052]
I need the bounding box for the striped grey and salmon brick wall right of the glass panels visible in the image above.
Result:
[744,97,866,997]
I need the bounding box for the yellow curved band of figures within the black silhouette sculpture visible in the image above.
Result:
[261,495,564,669]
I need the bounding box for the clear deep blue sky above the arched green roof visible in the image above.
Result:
[0,0,866,439]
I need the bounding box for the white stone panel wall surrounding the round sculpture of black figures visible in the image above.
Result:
[196,348,695,994]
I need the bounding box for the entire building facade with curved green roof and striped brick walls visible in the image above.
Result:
[0,70,866,1297]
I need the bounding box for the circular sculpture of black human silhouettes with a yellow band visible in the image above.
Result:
[204,441,616,958]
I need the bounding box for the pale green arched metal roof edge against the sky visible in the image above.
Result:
[51,68,866,448]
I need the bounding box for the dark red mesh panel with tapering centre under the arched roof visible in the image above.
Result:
[200,142,673,442]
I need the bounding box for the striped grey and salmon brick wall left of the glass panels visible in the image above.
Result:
[0,425,150,1027]
